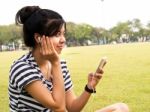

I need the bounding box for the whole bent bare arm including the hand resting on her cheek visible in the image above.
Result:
[26,36,65,112]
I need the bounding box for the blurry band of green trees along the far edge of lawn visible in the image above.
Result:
[0,19,150,47]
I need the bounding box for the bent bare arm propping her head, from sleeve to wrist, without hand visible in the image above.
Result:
[26,63,65,112]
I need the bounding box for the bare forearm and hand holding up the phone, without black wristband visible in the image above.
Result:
[66,59,106,112]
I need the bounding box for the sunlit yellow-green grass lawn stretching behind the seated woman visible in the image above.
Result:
[0,43,150,112]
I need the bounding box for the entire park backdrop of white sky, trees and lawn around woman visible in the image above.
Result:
[0,0,150,112]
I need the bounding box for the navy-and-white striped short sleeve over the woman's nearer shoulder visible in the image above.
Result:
[9,51,40,85]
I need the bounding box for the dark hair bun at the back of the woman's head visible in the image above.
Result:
[15,6,41,24]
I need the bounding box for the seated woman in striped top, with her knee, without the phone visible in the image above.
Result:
[9,6,128,112]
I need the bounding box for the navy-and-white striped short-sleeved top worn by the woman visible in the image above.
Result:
[8,52,72,112]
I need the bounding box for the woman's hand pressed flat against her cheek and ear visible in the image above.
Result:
[40,35,60,64]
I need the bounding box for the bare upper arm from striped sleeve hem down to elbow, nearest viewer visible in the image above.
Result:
[25,81,64,112]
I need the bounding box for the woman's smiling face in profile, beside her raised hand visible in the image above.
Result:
[50,25,66,54]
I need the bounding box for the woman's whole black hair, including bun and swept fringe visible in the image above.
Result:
[15,6,66,48]
